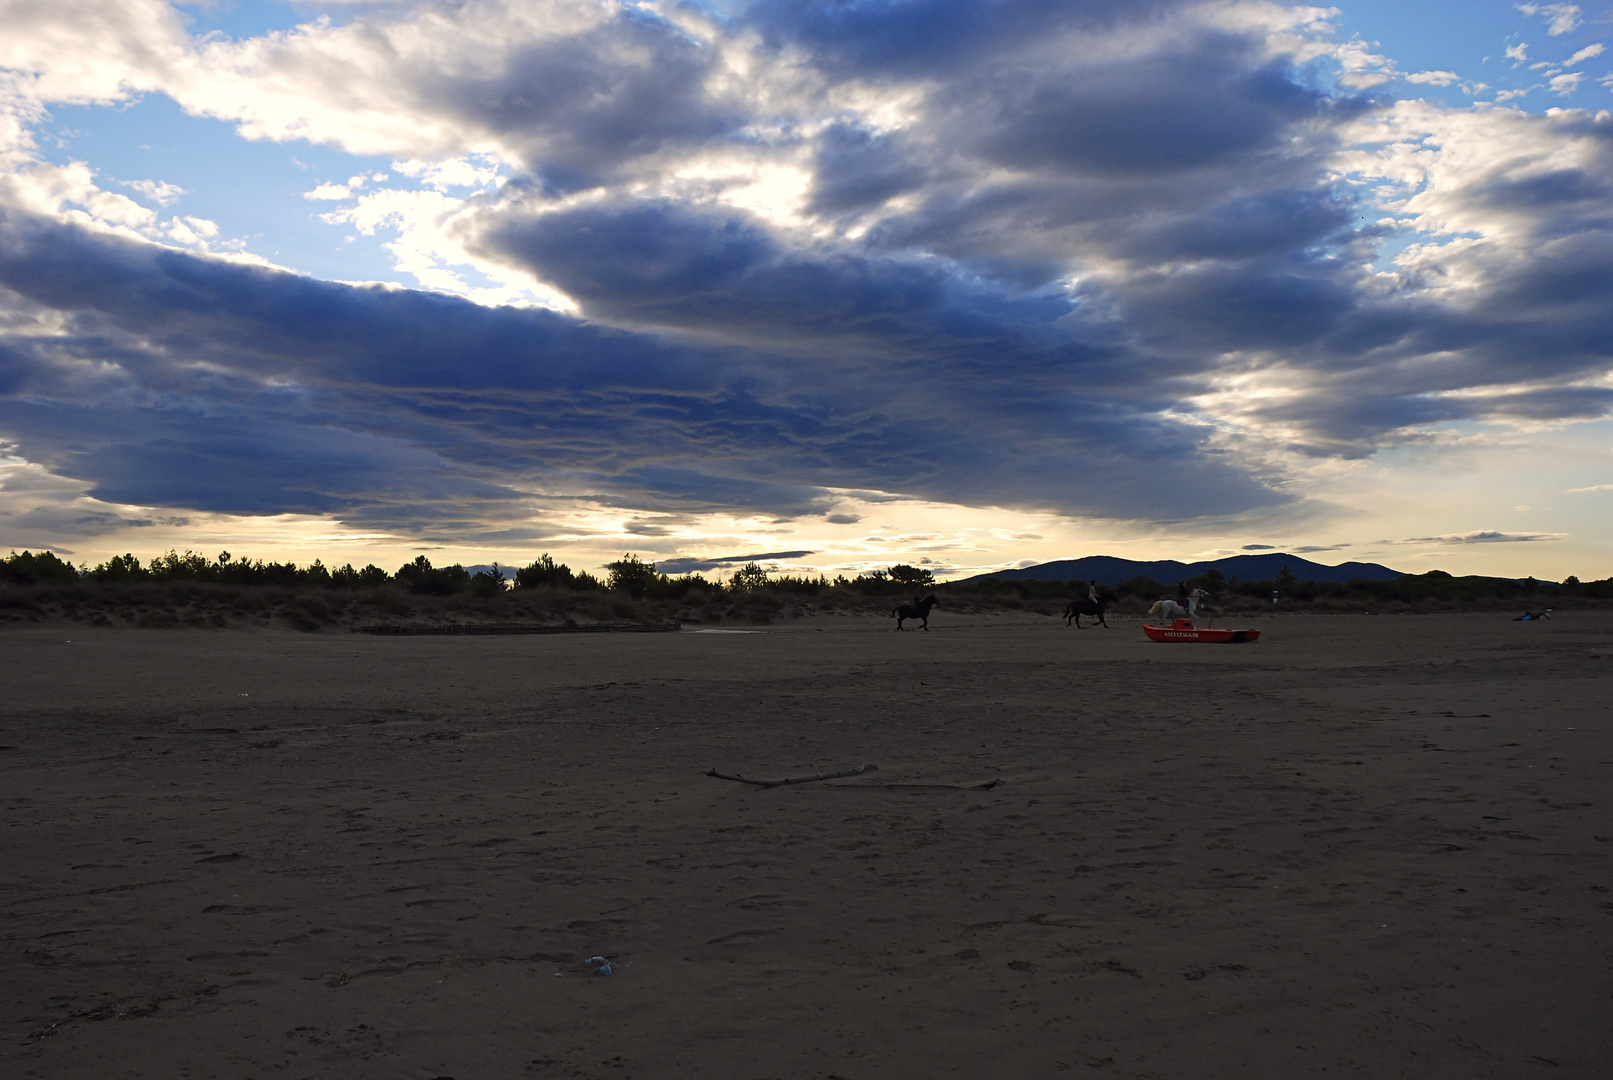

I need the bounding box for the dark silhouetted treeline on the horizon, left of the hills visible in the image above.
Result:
[0,551,936,600]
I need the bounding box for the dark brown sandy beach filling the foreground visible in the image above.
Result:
[0,611,1613,1080]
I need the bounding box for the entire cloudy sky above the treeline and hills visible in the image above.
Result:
[0,0,1613,580]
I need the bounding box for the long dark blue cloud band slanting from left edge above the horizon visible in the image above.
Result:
[0,203,1274,521]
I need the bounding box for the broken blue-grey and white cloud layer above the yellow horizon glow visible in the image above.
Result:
[0,0,1613,554]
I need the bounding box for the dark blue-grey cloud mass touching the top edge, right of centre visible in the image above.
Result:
[752,3,1371,289]
